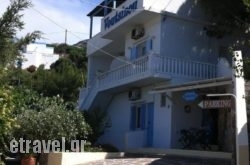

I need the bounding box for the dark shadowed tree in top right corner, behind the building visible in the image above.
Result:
[198,0,250,80]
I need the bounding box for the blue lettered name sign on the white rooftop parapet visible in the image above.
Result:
[104,1,137,30]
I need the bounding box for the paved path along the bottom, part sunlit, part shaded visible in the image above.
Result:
[81,156,231,165]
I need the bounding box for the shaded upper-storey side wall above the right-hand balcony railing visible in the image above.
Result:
[161,16,218,64]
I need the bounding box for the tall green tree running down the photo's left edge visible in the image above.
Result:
[0,0,40,155]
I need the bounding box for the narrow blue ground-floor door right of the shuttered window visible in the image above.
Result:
[147,103,154,147]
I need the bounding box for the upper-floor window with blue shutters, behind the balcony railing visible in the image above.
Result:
[130,39,153,60]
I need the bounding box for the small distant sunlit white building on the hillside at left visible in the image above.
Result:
[22,43,59,69]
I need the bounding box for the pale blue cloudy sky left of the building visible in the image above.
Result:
[0,0,101,45]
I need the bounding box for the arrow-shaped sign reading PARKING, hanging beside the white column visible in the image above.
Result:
[198,100,232,109]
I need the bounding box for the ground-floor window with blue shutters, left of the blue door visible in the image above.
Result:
[130,104,146,130]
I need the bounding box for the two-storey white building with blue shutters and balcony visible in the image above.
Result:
[79,0,249,152]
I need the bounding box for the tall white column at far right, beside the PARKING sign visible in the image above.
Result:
[232,51,249,165]
